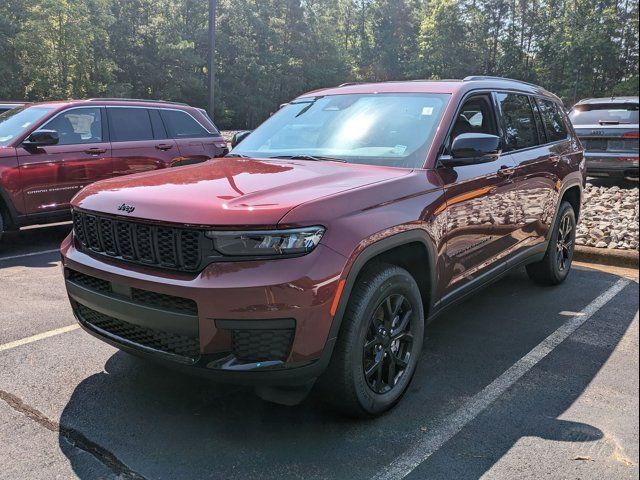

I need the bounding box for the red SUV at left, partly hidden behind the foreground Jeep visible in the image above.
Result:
[0,99,228,240]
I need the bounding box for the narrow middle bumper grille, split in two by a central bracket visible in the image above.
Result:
[67,268,198,315]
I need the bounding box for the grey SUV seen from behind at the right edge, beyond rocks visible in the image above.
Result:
[569,97,638,180]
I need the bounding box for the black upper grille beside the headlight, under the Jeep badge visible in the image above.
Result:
[73,210,204,272]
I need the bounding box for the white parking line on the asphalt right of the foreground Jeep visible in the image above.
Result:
[374,278,630,480]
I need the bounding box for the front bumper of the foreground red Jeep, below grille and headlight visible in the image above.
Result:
[61,233,346,385]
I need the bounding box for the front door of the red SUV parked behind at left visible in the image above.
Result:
[17,107,112,214]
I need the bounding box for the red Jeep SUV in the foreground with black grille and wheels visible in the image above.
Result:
[61,77,585,416]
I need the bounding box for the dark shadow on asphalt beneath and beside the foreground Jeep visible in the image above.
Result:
[60,269,637,479]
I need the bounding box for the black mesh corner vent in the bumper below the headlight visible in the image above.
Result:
[231,328,294,363]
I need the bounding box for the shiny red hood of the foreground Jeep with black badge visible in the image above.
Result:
[72,158,410,226]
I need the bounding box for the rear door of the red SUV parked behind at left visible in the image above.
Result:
[107,106,180,176]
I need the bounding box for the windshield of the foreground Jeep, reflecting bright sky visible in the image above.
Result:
[233,93,449,168]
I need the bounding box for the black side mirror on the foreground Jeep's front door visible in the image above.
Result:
[440,133,502,167]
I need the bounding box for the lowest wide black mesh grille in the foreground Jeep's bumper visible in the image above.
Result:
[75,303,200,360]
